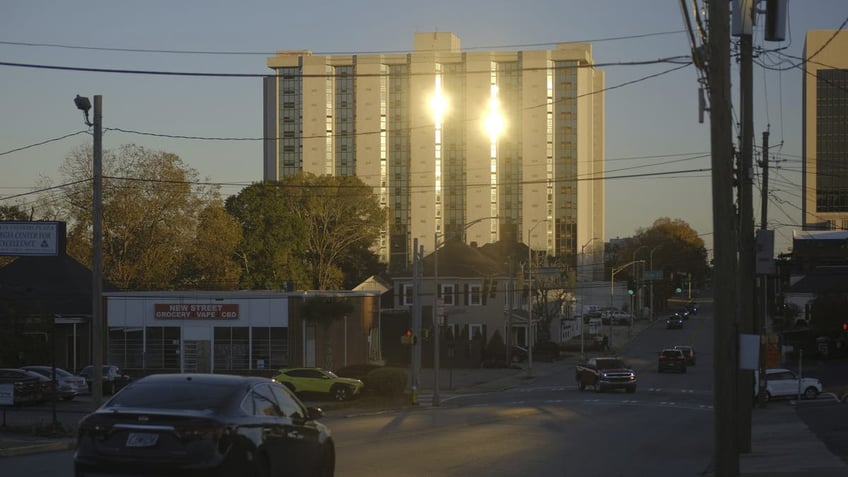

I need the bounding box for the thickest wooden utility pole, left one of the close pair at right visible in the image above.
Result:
[707,2,739,477]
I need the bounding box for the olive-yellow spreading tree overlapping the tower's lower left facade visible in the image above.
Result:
[283,174,385,290]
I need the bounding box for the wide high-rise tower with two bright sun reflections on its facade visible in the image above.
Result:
[264,32,604,280]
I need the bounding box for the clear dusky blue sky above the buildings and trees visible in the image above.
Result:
[0,0,848,252]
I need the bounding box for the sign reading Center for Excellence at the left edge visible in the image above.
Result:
[0,220,65,257]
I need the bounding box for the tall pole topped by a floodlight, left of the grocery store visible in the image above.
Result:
[74,94,104,408]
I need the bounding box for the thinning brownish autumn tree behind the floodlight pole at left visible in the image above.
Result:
[48,145,225,290]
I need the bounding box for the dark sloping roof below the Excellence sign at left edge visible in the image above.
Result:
[0,254,117,316]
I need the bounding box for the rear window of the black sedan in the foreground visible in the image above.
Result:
[108,380,238,411]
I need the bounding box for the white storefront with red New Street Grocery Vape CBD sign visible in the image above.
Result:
[103,291,291,373]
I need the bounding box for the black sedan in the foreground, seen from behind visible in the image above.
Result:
[74,374,335,477]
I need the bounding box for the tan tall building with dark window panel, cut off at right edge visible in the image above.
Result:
[802,30,848,230]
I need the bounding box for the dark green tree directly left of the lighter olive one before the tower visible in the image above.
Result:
[226,182,310,290]
